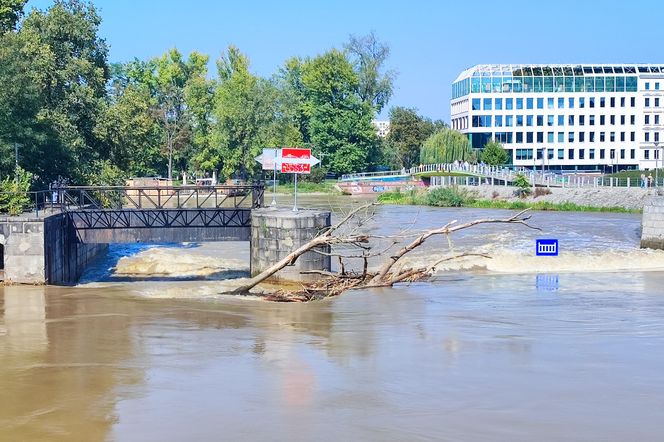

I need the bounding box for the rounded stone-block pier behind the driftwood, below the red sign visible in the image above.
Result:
[251,208,331,281]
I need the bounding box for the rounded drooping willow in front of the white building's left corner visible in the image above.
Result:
[420,127,477,164]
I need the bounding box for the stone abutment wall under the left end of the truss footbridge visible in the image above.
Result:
[0,214,107,285]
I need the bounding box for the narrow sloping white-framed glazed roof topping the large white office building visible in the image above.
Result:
[454,64,664,82]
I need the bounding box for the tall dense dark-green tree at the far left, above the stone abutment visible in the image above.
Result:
[0,0,108,185]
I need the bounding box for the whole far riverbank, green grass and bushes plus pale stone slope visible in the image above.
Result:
[378,186,655,212]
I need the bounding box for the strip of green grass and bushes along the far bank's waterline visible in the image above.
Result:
[378,186,641,213]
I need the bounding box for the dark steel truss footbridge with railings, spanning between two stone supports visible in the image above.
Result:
[49,183,264,243]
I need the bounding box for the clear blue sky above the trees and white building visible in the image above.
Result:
[27,0,664,121]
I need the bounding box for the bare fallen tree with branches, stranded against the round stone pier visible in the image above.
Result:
[231,203,539,301]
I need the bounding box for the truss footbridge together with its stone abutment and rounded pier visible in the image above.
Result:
[0,184,330,285]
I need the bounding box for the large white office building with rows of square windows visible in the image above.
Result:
[451,64,664,171]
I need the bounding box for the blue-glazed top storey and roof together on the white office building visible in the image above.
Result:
[452,65,648,99]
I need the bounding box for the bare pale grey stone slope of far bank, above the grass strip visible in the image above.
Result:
[461,186,655,210]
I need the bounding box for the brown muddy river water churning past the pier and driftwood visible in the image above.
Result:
[0,201,664,441]
